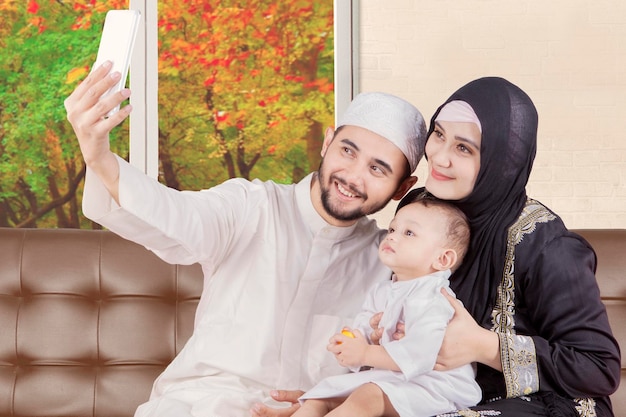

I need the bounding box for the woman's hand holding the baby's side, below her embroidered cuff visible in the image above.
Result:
[434,289,502,371]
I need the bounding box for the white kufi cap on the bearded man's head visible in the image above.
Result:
[337,92,426,173]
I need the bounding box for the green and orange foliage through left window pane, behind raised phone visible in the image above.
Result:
[0,0,127,227]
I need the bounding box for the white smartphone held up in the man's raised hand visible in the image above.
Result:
[92,10,141,116]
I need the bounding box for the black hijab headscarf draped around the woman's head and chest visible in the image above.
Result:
[398,77,537,323]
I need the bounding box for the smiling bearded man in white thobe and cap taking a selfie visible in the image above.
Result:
[65,64,426,417]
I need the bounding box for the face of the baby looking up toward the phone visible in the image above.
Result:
[378,203,447,280]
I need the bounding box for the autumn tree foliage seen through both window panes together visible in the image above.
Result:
[0,0,333,227]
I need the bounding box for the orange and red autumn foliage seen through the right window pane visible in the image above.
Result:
[159,0,334,189]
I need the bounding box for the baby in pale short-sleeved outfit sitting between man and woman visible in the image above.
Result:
[293,196,481,417]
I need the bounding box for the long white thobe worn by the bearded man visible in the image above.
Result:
[83,158,390,417]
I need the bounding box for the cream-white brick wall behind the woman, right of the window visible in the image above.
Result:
[359,0,626,228]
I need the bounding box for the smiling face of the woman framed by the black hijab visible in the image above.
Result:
[426,121,481,200]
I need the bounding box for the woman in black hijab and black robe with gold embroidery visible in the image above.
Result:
[399,77,620,417]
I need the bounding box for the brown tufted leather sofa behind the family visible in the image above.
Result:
[0,228,626,417]
